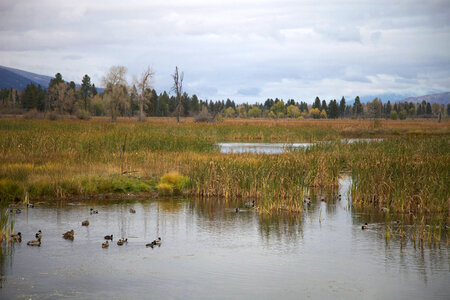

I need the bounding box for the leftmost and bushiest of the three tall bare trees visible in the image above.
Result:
[102,66,128,121]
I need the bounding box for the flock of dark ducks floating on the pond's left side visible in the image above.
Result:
[11,204,162,248]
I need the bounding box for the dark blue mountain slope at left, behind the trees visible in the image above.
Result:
[0,66,52,91]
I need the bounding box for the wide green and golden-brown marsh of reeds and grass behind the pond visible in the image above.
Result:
[0,118,450,219]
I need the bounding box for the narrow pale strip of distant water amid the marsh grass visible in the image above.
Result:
[217,139,383,154]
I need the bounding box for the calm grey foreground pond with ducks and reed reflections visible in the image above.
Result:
[0,180,450,299]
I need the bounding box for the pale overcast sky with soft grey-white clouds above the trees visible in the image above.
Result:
[0,0,450,103]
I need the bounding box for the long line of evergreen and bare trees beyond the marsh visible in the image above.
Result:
[0,66,450,121]
